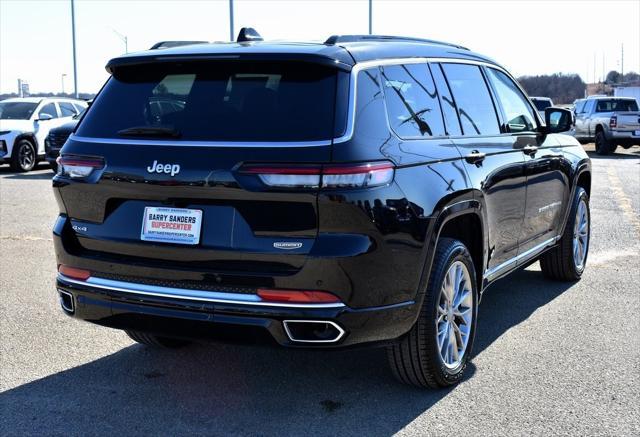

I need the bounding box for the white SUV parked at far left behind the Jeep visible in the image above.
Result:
[0,97,87,171]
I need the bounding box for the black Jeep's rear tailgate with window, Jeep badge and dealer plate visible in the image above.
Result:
[54,61,348,274]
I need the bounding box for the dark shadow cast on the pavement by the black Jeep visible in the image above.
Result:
[0,264,571,435]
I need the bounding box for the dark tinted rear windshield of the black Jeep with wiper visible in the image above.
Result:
[76,61,343,141]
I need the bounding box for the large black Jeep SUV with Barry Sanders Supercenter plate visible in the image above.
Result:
[53,31,591,387]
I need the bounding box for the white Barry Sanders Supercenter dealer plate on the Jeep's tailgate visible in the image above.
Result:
[140,207,202,244]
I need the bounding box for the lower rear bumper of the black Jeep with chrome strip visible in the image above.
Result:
[56,275,418,348]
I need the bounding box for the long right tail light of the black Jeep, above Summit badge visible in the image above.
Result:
[240,162,394,188]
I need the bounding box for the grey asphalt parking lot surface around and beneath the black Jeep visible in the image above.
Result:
[0,146,640,435]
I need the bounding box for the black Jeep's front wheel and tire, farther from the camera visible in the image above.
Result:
[540,187,591,281]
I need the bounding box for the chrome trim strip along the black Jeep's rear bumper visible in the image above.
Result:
[58,273,346,309]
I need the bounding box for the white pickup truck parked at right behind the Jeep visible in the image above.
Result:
[574,97,640,155]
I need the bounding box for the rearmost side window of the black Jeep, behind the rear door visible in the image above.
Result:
[382,64,446,138]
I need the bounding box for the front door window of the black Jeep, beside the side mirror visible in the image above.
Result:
[485,68,536,132]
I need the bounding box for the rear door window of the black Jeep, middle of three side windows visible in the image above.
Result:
[442,64,500,135]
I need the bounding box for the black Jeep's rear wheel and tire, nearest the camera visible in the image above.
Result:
[387,238,478,388]
